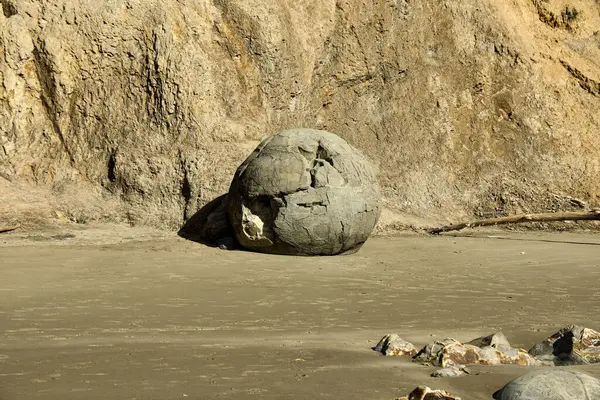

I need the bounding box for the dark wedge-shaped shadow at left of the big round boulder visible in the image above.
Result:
[177,194,240,250]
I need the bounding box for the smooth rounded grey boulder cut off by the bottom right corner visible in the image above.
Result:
[494,369,600,400]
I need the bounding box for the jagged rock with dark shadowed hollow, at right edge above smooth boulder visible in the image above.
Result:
[529,325,600,365]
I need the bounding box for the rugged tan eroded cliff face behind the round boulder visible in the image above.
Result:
[0,0,600,227]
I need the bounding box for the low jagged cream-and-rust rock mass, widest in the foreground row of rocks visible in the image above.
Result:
[414,333,540,368]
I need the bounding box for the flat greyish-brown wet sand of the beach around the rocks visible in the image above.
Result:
[0,232,600,400]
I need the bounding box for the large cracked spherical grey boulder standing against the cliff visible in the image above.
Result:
[229,129,381,255]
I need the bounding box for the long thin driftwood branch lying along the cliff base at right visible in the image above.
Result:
[427,209,600,235]
